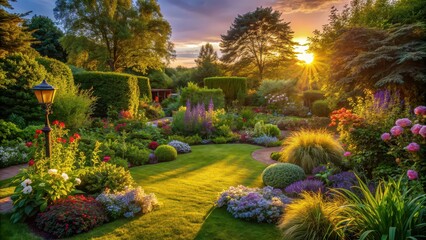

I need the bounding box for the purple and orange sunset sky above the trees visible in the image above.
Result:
[12,0,350,67]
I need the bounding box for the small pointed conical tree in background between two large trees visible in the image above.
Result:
[191,43,220,86]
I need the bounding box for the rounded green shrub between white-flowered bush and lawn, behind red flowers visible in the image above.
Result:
[78,162,134,193]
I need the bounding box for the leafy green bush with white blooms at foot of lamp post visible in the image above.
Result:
[11,167,81,223]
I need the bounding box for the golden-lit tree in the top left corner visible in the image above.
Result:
[0,0,32,58]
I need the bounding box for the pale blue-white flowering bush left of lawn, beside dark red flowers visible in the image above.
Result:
[96,187,159,219]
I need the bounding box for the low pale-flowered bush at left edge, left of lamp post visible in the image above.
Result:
[0,144,30,168]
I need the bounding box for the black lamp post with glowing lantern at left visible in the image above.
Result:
[33,80,56,158]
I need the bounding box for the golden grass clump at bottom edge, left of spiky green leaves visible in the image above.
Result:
[278,192,344,240]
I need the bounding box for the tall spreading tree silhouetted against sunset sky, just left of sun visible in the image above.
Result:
[220,7,295,80]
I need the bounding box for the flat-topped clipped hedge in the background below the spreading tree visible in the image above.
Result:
[204,77,247,104]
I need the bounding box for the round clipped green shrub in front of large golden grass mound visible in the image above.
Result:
[262,163,305,188]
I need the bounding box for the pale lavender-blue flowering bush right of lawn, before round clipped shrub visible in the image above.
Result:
[216,185,290,223]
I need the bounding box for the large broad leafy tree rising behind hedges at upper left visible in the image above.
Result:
[54,0,173,72]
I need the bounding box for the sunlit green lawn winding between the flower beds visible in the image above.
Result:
[2,144,280,240]
